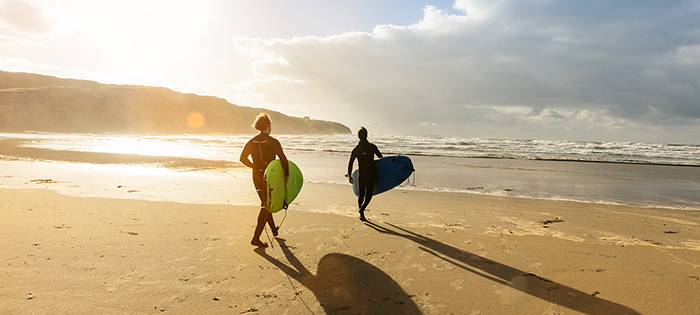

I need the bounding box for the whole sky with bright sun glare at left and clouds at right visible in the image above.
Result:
[0,0,700,144]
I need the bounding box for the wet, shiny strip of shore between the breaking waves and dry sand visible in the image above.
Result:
[0,135,700,211]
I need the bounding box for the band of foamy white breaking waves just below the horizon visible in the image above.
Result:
[5,133,700,166]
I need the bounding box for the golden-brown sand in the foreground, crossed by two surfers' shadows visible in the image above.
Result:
[0,183,700,314]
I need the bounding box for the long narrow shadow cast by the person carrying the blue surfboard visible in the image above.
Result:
[365,222,640,314]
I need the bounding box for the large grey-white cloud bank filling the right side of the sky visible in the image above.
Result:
[234,0,700,141]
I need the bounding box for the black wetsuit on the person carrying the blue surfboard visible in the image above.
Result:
[348,140,382,212]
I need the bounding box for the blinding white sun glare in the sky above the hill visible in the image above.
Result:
[59,0,212,78]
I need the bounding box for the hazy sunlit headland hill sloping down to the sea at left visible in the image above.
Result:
[0,71,350,134]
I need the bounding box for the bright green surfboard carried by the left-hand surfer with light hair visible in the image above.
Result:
[265,160,304,213]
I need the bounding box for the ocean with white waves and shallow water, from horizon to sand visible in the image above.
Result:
[0,133,700,210]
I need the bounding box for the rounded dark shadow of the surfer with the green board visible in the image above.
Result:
[255,238,421,314]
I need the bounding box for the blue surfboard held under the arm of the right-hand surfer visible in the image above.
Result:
[352,155,415,196]
